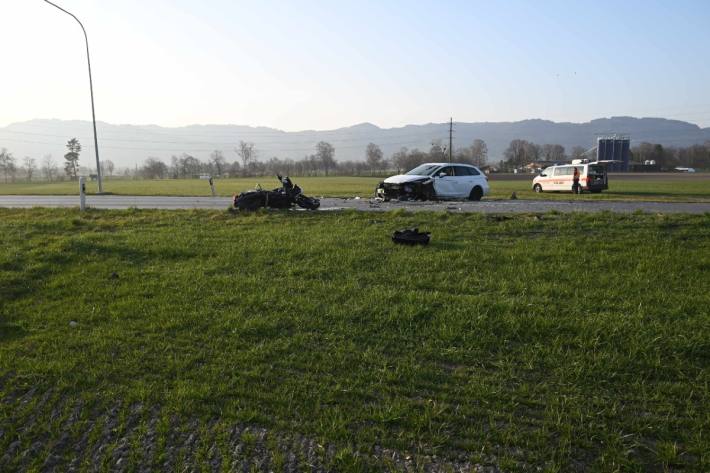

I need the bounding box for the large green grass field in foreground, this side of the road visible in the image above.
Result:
[0,209,710,472]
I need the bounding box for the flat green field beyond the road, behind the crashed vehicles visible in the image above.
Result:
[0,174,710,202]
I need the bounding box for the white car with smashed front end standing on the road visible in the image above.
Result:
[375,163,490,200]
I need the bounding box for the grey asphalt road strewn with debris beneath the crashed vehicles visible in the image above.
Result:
[0,195,710,214]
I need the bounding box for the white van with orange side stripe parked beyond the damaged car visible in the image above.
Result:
[533,163,609,194]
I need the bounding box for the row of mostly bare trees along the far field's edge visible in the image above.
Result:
[0,138,710,183]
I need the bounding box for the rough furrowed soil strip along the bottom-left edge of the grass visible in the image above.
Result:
[0,389,506,473]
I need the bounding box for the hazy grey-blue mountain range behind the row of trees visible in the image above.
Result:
[0,117,710,167]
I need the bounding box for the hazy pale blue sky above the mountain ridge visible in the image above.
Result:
[0,0,710,131]
